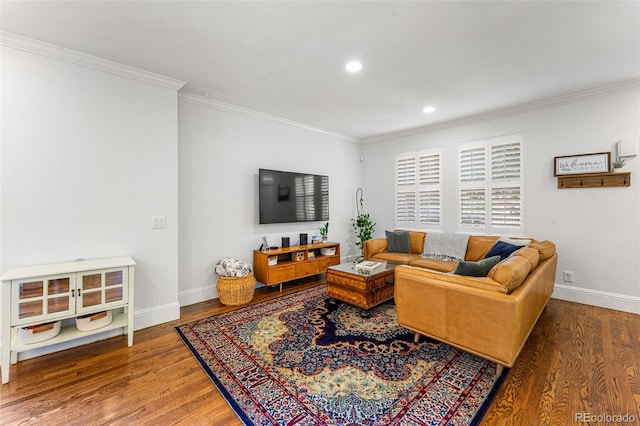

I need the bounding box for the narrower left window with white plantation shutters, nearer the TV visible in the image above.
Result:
[396,150,441,228]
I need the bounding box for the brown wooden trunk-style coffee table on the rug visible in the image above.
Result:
[327,262,396,317]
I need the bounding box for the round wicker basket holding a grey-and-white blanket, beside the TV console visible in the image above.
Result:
[215,257,255,306]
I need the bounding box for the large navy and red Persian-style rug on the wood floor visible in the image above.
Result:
[176,285,506,425]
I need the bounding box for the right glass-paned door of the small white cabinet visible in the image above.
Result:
[77,268,129,314]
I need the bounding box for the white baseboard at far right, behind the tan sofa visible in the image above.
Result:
[551,284,640,315]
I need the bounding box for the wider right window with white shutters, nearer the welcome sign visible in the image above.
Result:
[458,135,523,233]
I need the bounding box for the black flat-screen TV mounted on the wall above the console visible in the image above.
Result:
[258,169,329,224]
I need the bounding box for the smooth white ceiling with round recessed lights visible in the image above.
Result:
[0,0,640,140]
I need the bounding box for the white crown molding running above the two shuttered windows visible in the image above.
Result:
[360,78,640,143]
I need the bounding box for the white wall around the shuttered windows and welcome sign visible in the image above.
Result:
[363,90,640,313]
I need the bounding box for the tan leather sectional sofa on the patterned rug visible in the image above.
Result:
[363,231,558,372]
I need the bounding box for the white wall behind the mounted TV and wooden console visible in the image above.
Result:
[179,95,362,305]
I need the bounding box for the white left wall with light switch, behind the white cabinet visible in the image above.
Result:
[0,46,179,346]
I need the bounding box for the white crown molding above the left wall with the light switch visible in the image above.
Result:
[0,31,186,91]
